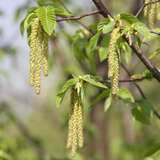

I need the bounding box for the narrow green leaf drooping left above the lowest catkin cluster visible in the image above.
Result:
[56,78,76,106]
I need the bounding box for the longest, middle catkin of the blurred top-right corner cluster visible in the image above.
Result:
[148,0,155,29]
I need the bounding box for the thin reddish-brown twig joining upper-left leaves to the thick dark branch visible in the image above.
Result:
[56,11,100,22]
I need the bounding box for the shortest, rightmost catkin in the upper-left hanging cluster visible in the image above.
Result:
[43,32,49,76]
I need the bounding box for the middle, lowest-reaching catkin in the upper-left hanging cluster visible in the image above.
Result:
[35,26,42,94]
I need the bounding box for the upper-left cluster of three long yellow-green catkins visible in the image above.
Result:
[30,18,48,94]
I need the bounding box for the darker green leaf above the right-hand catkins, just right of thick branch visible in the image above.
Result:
[120,13,139,25]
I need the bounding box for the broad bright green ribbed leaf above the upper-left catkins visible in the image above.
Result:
[36,6,56,35]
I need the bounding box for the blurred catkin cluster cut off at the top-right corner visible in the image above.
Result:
[144,0,160,29]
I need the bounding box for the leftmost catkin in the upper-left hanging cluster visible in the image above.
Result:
[30,18,40,86]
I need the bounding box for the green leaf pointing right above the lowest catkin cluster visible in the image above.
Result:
[82,75,107,88]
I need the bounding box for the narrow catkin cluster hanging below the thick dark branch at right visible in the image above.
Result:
[108,27,120,95]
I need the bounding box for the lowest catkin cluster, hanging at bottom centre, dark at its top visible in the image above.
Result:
[67,88,83,156]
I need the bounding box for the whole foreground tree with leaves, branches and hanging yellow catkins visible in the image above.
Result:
[17,0,160,160]
